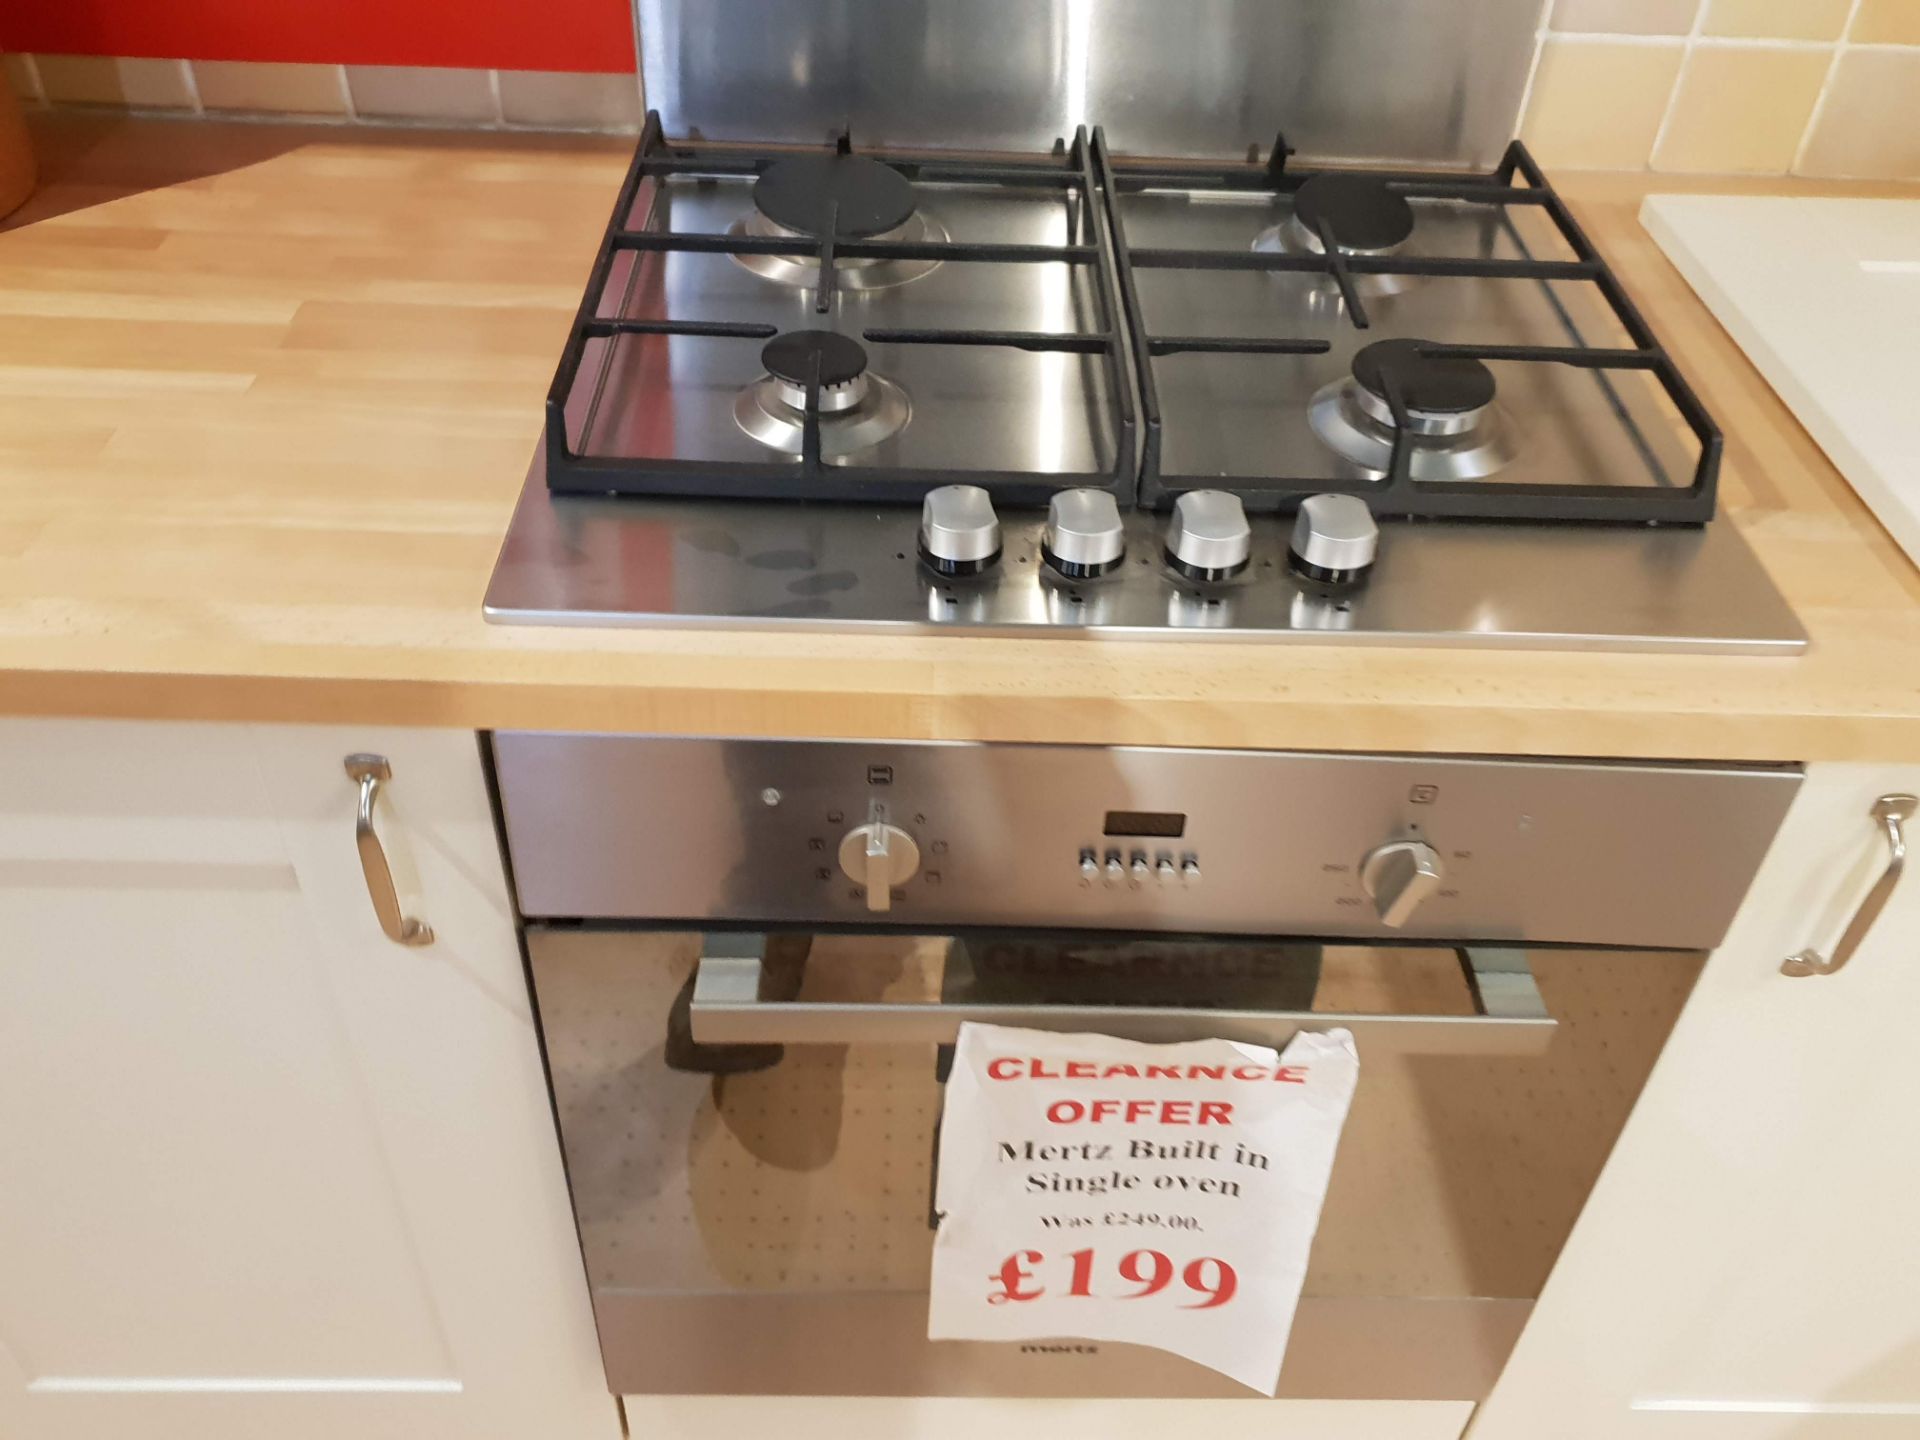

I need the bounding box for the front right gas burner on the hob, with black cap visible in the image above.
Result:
[1308,340,1517,480]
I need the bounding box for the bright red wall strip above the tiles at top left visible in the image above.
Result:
[0,0,634,71]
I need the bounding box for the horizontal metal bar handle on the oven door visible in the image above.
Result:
[691,948,1557,1056]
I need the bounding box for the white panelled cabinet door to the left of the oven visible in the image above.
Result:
[0,720,618,1440]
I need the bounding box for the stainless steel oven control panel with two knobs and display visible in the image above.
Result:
[493,732,1799,960]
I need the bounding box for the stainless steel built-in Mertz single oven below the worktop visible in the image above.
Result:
[493,732,1799,1400]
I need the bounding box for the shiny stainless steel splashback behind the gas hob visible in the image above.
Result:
[634,0,1542,165]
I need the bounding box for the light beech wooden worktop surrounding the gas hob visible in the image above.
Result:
[0,117,1920,760]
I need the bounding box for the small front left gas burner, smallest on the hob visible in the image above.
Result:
[733,330,914,461]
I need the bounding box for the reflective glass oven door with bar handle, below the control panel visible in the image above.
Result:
[528,924,1701,1400]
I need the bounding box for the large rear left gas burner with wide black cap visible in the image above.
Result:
[728,154,948,290]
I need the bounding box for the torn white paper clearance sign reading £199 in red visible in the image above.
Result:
[927,1025,1359,1394]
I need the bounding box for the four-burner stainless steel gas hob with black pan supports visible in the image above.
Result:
[486,117,1805,653]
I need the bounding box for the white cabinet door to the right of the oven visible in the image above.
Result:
[1469,766,1920,1440]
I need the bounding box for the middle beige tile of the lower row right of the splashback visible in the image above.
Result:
[1653,44,1834,175]
